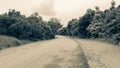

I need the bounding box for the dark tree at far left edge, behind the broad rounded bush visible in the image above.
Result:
[0,9,22,35]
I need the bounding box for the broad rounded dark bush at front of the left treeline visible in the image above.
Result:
[9,18,55,40]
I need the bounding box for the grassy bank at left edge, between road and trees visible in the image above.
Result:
[0,35,22,50]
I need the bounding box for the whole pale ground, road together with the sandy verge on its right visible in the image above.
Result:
[0,36,120,68]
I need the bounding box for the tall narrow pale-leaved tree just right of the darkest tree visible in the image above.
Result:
[87,7,104,38]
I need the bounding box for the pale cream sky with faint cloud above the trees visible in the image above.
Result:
[0,0,120,25]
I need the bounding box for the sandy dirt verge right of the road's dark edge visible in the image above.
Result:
[77,39,120,68]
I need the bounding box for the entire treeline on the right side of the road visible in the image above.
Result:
[58,2,120,45]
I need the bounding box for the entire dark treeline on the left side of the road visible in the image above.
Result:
[0,9,62,41]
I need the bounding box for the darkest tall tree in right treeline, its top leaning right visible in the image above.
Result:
[78,9,95,38]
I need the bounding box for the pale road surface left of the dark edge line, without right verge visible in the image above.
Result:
[0,36,89,68]
